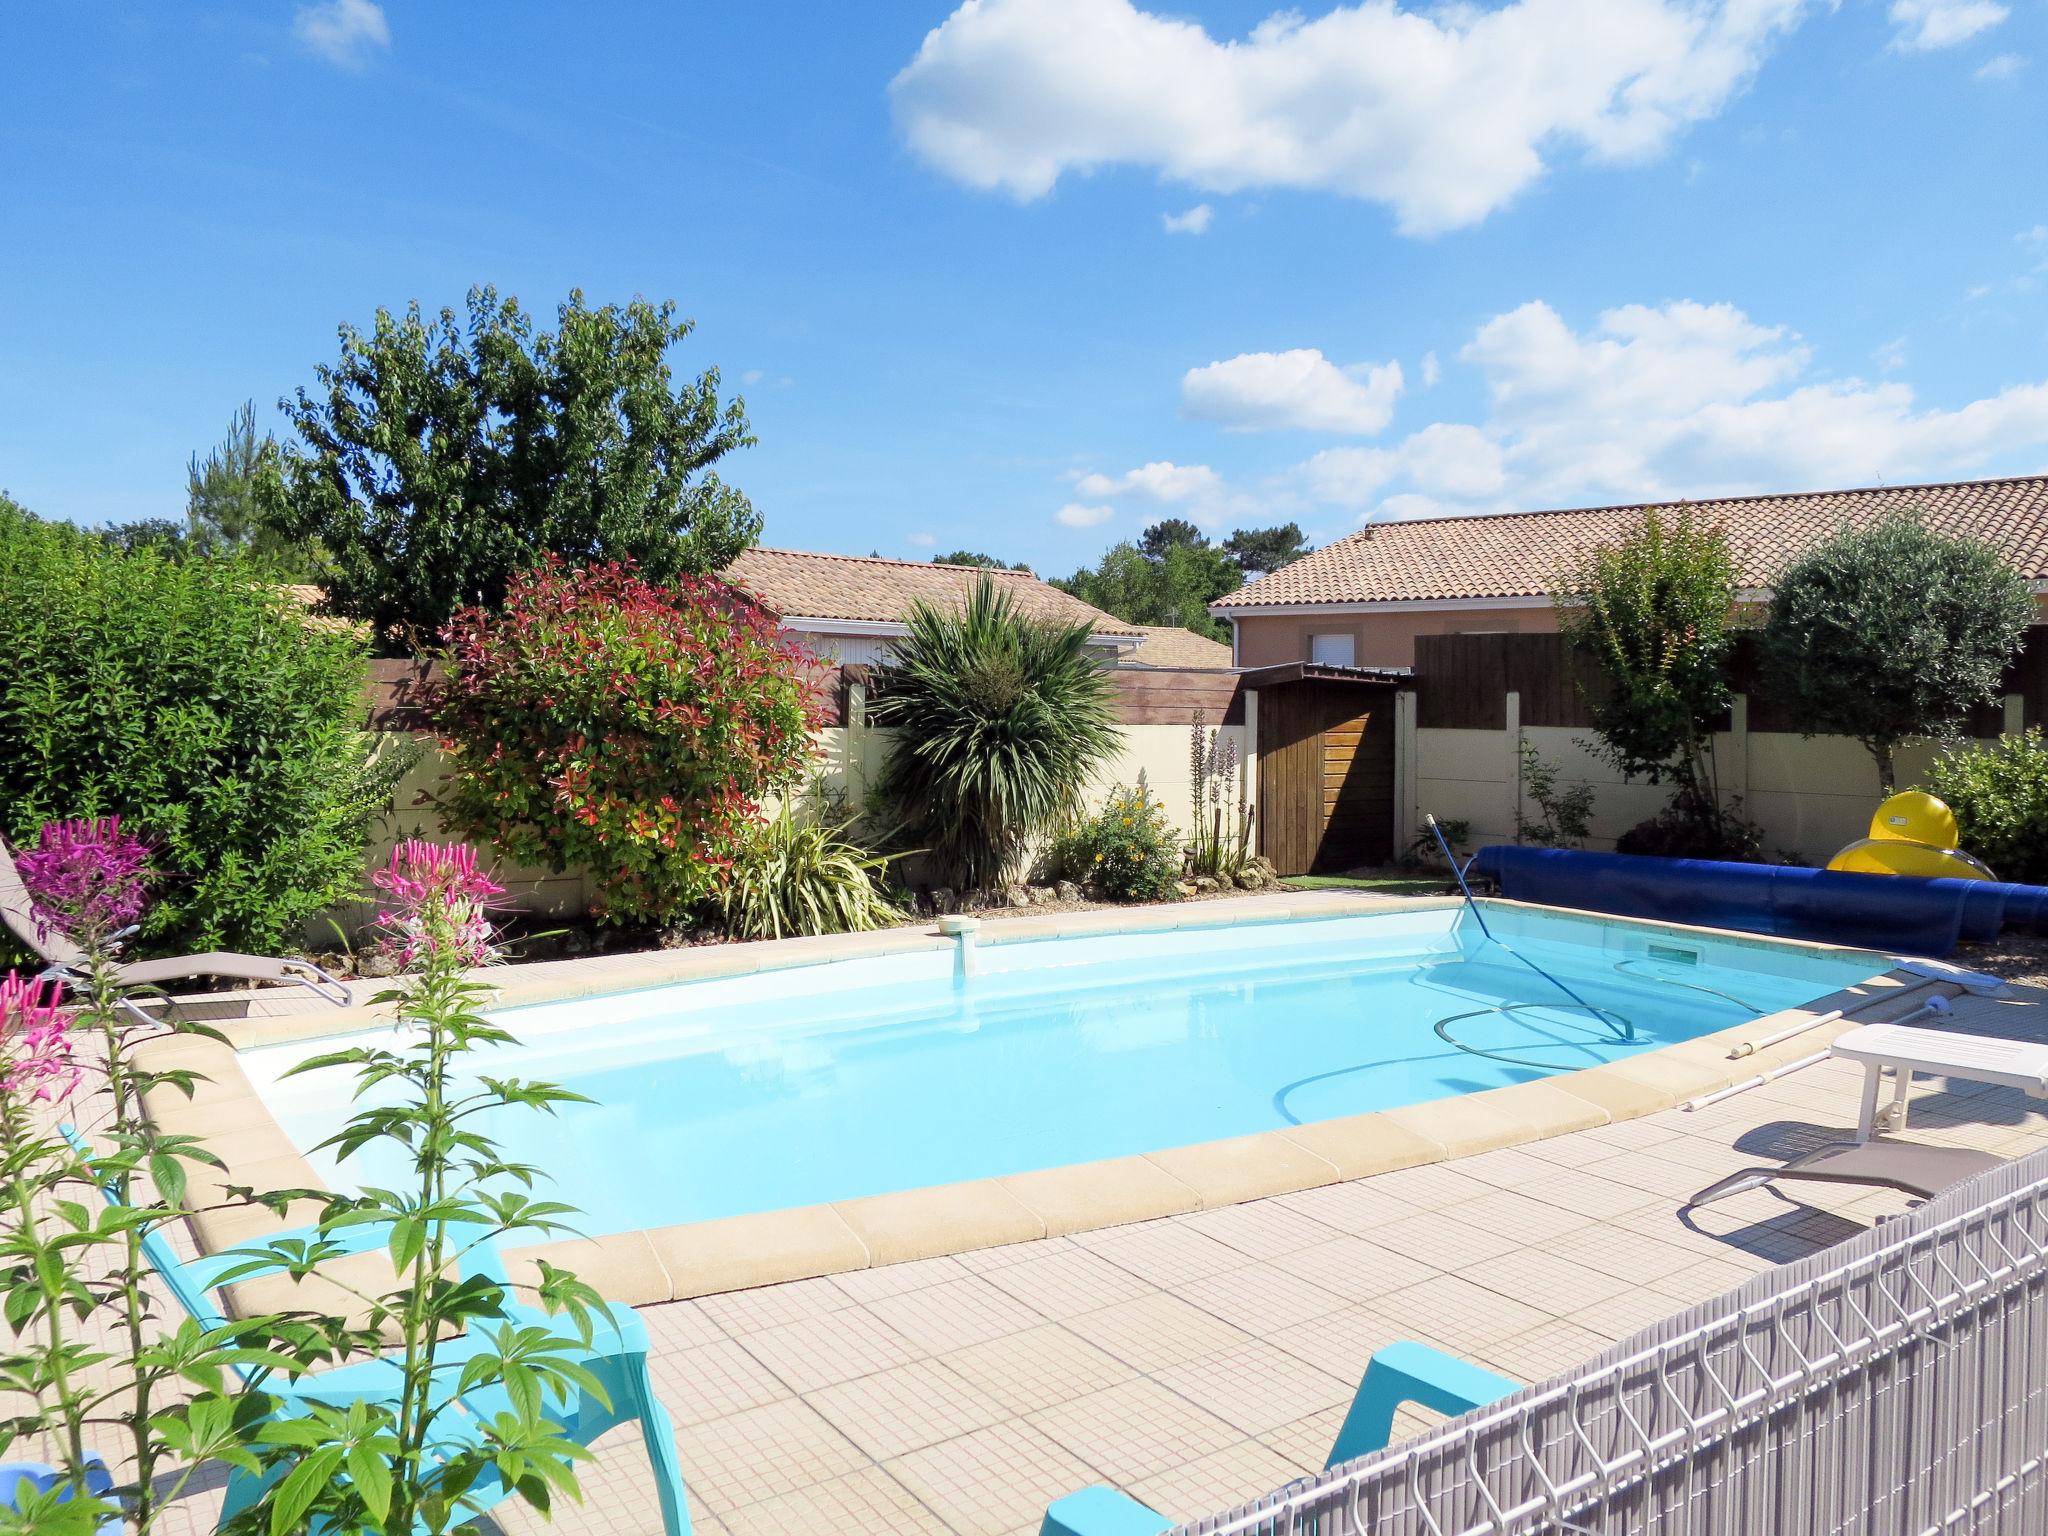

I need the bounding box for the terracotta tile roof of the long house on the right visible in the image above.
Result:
[1210,475,2048,608]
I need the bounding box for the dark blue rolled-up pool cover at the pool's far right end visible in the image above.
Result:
[1468,844,2048,954]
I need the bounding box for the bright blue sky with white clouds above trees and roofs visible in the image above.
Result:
[0,0,2048,573]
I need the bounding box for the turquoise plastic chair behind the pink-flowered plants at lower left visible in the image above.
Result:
[63,1126,690,1536]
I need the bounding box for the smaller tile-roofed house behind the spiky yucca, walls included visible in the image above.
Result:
[721,549,1155,666]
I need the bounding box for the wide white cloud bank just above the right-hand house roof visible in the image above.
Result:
[1294,301,2048,516]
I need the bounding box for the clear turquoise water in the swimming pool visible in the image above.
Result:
[244,909,1888,1233]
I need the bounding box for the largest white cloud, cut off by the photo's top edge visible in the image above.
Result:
[889,0,1810,233]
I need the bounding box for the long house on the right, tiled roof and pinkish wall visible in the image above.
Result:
[1210,475,2048,668]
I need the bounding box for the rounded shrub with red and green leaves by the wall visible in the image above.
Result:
[432,557,817,922]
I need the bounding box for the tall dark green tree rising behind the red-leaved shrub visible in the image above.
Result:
[264,287,760,647]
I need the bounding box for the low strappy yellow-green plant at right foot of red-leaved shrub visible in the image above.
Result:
[721,801,901,938]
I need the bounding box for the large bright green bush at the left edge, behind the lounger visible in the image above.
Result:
[0,498,403,954]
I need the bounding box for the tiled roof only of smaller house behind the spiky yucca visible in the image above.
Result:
[723,549,1139,635]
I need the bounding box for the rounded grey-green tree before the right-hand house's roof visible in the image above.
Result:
[1763,514,2034,795]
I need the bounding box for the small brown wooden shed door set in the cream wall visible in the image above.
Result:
[1260,676,1395,874]
